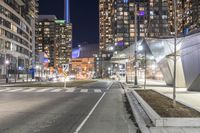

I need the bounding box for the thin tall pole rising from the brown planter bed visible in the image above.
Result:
[173,0,177,107]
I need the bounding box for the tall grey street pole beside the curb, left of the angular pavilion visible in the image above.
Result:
[134,2,138,86]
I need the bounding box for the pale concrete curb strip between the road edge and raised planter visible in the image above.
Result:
[121,83,151,133]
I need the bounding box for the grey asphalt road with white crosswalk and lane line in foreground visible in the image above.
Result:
[0,81,137,133]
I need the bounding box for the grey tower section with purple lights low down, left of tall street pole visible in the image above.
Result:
[112,0,130,50]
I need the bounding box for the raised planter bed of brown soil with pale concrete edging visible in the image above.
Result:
[133,90,200,127]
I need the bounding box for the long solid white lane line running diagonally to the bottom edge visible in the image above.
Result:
[74,92,106,133]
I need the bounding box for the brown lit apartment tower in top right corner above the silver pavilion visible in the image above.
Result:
[168,0,200,36]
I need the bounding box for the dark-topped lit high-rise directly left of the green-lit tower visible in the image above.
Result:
[35,15,57,67]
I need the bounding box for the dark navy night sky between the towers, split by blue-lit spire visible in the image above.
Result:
[39,0,99,47]
